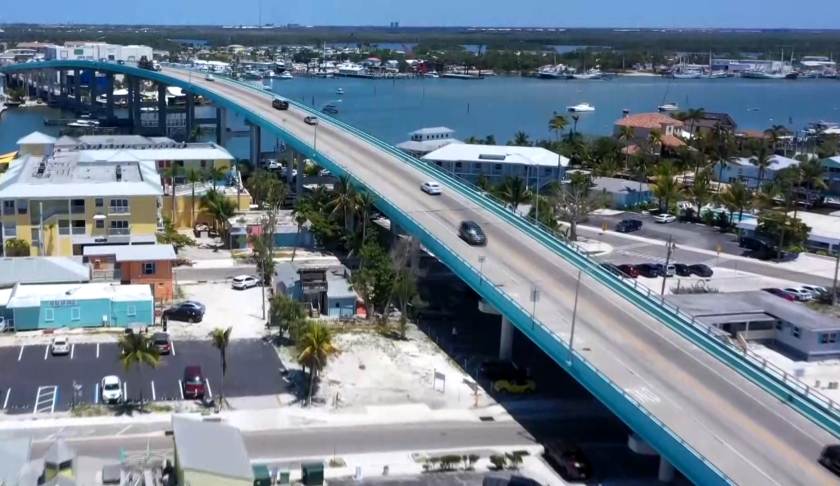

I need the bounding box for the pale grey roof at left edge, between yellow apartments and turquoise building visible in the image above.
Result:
[0,257,90,287]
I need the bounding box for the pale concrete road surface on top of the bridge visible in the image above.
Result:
[163,68,840,486]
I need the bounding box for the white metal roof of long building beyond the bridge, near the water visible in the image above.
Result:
[423,143,569,167]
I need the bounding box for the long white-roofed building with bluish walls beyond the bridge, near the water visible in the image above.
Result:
[422,143,569,188]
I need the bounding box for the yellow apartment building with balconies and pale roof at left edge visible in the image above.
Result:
[0,132,163,256]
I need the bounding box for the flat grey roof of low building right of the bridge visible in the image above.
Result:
[665,291,840,331]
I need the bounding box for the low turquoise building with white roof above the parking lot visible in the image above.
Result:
[0,283,155,331]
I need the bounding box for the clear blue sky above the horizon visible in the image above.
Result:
[0,0,840,29]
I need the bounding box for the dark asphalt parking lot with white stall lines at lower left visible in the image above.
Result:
[0,339,286,413]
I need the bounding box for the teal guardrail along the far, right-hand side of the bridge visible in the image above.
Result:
[184,63,840,437]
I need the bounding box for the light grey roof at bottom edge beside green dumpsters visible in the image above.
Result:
[172,415,254,481]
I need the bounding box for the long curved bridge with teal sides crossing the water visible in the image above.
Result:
[0,61,840,486]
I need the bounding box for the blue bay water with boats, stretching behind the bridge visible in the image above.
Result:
[0,77,840,157]
